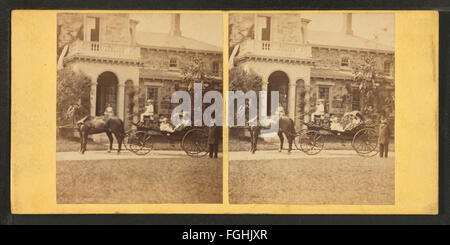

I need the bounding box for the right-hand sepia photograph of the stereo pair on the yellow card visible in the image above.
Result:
[228,12,395,205]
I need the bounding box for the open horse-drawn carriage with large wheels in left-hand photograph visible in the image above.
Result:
[124,117,208,157]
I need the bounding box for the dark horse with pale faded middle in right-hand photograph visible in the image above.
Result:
[249,116,295,154]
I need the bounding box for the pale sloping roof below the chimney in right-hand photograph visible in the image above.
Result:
[308,30,394,52]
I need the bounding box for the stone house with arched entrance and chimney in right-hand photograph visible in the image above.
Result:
[229,13,394,127]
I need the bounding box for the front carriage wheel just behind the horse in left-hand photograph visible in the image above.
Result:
[124,131,153,155]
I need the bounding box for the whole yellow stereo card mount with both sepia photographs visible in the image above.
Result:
[10,9,440,216]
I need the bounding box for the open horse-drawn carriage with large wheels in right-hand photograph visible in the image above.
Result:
[294,111,378,157]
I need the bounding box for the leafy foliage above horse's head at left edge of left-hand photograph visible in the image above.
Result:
[56,67,91,126]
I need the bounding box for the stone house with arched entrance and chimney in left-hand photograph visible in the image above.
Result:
[58,13,223,127]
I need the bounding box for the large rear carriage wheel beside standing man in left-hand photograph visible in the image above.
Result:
[181,129,208,157]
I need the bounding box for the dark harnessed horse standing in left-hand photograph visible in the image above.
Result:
[77,116,125,154]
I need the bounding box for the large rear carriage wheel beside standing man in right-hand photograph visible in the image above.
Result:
[352,128,378,157]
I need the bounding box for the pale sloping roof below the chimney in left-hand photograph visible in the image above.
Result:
[136,32,223,52]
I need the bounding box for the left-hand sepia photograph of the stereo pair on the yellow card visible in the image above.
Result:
[56,13,223,204]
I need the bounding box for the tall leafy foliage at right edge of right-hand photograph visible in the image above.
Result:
[354,56,395,120]
